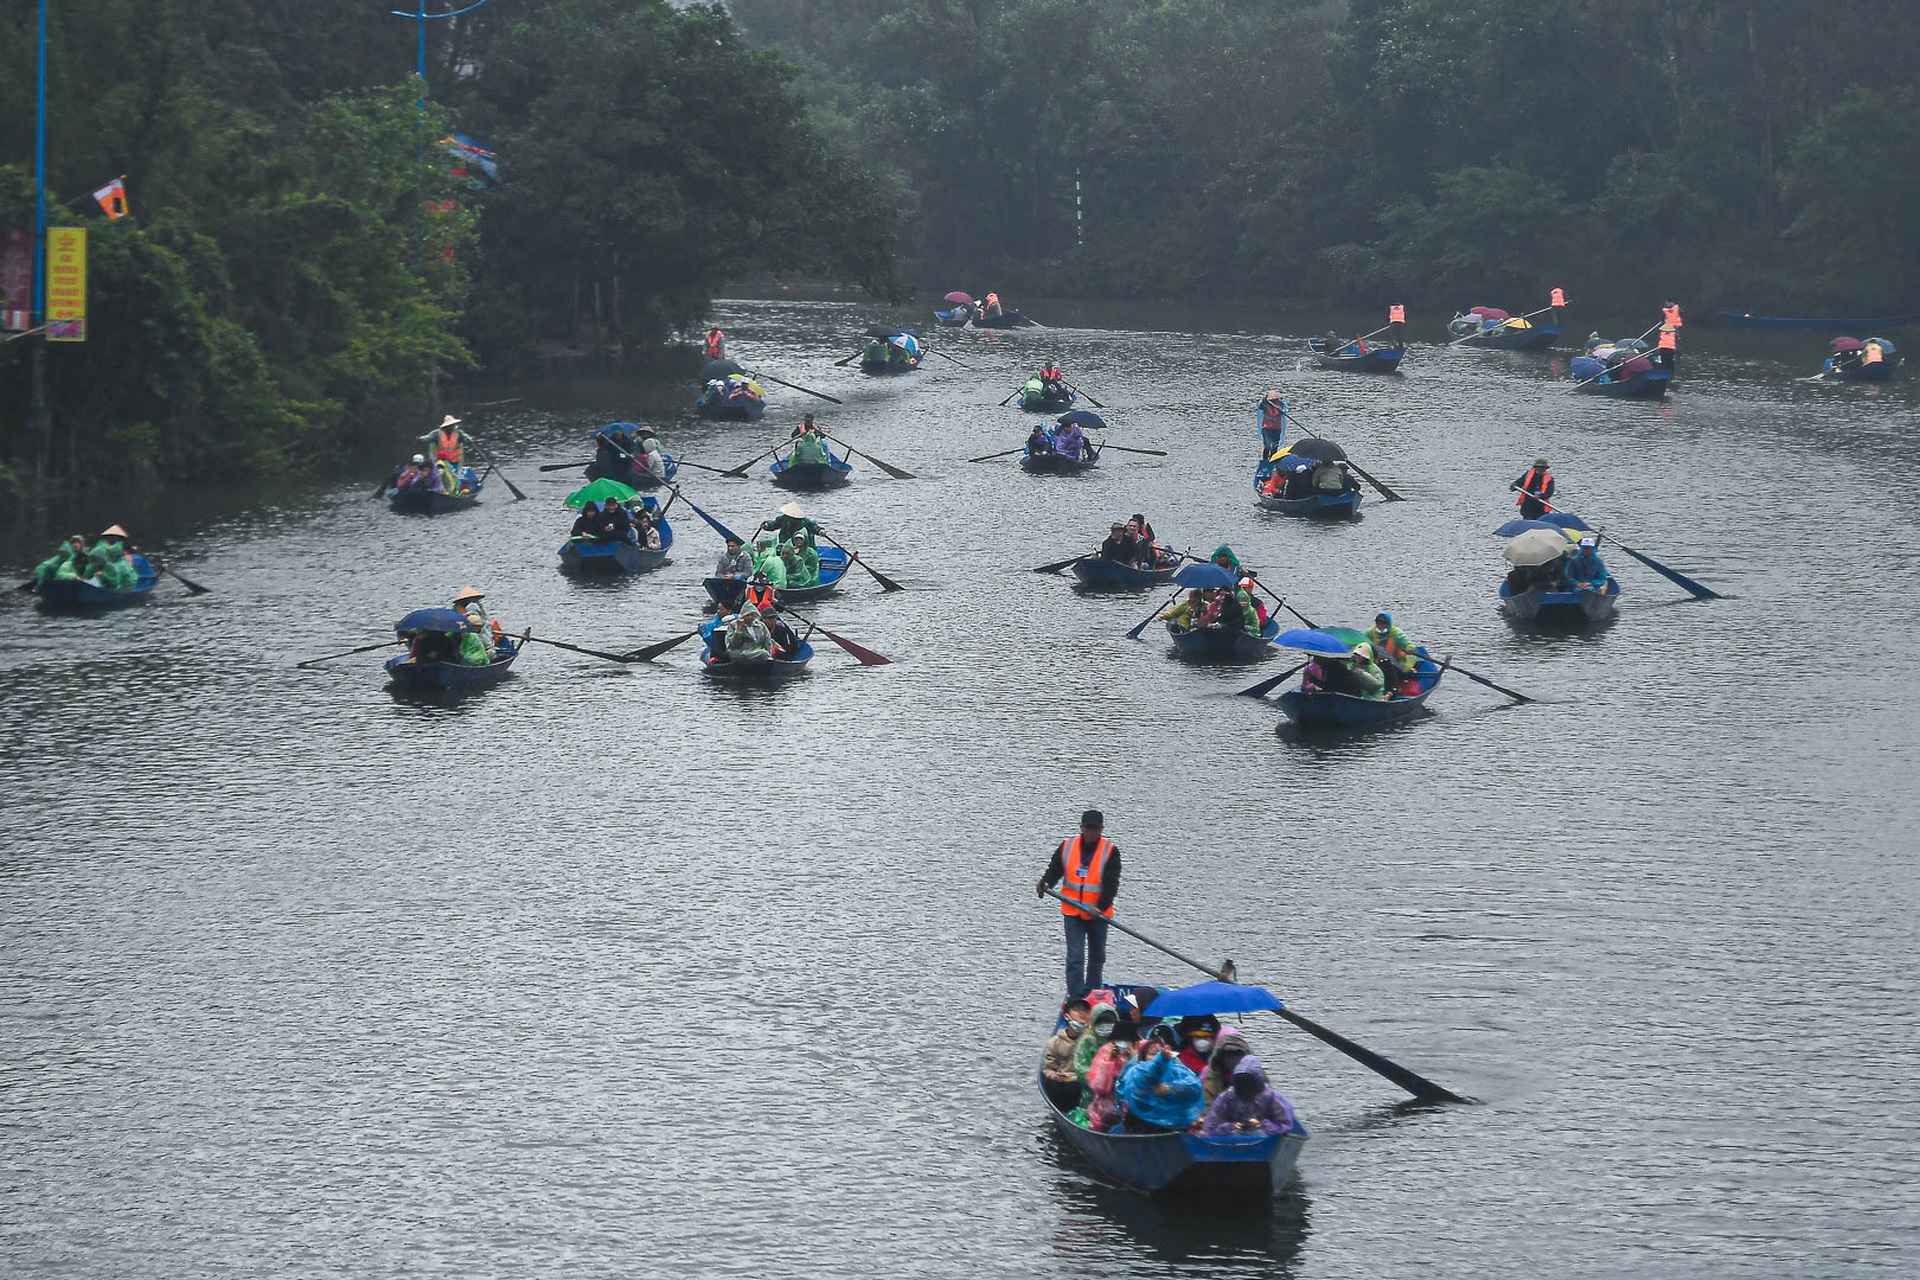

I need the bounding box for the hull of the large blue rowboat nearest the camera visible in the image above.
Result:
[1035,983,1309,1203]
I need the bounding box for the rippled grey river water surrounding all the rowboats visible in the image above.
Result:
[0,301,1920,1278]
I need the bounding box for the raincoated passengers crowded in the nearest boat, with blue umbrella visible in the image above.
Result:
[1041,986,1294,1138]
